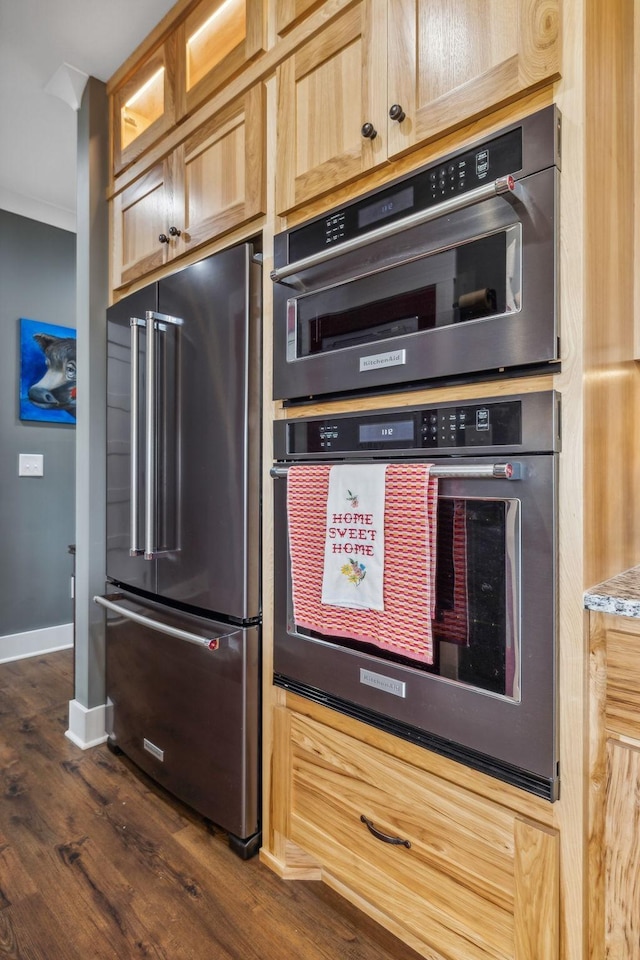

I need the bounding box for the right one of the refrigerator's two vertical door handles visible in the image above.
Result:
[144,310,183,560]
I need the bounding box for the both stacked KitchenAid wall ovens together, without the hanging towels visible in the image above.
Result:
[272,107,560,800]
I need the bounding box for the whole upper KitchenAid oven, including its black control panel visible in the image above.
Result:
[271,107,560,400]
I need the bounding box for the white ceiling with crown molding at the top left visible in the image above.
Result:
[0,0,175,230]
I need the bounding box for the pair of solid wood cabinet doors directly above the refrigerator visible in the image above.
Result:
[112,84,265,288]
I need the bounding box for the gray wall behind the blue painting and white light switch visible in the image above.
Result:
[0,210,76,636]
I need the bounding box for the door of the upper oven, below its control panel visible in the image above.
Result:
[274,168,558,399]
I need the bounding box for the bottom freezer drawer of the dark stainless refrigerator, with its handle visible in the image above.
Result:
[101,594,260,840]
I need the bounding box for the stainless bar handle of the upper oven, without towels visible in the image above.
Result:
[270,174,522,283]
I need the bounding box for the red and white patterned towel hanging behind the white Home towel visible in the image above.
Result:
[287,464,438,663]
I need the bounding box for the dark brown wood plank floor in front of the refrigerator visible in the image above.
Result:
[0,651,418,960]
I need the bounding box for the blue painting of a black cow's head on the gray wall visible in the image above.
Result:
[20,319,76,423]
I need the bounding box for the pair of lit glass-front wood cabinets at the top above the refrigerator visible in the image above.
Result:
[110,0,264,175]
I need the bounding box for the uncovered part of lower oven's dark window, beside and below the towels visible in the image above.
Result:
[289,496,520,700]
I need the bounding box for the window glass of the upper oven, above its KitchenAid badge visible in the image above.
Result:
[288,224,521,360]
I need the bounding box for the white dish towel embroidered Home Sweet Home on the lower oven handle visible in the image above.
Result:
[322,464,387,610]
